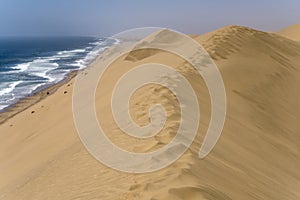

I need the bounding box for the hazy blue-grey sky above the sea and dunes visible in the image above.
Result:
[0,0,300,36]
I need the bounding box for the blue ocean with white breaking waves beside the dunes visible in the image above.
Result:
[0,37,117,111]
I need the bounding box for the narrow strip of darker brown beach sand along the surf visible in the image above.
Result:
[0,69,78,125]
